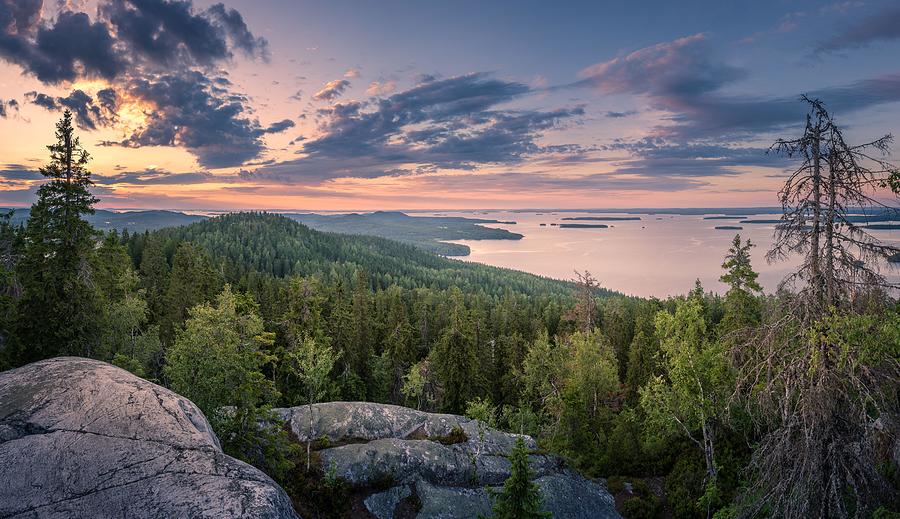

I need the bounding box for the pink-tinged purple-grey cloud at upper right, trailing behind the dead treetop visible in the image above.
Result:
[576,34,900,143]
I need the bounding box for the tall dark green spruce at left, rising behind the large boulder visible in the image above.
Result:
[16,110,99,363]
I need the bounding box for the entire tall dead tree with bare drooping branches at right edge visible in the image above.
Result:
[738,96,900,518]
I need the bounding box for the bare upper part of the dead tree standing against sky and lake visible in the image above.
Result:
[767,96,900,321]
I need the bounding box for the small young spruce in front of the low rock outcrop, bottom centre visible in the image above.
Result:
[490,438,550,519]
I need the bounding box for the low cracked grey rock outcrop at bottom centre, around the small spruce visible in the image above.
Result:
[276,402,619,519]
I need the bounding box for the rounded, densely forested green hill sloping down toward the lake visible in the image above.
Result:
[142,213,571,295]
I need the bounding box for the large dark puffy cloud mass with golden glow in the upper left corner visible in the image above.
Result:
[0,0,276,167]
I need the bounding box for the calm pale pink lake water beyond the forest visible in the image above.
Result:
[422,211,900,297]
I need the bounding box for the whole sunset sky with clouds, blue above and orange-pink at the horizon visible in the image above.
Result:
[0,0,900,211]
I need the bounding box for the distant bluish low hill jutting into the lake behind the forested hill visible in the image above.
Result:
[284,211,522,256]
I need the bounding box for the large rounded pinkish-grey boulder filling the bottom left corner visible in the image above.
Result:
[0,357,297,519]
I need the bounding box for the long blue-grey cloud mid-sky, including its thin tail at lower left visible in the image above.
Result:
[244,73,584,184]
